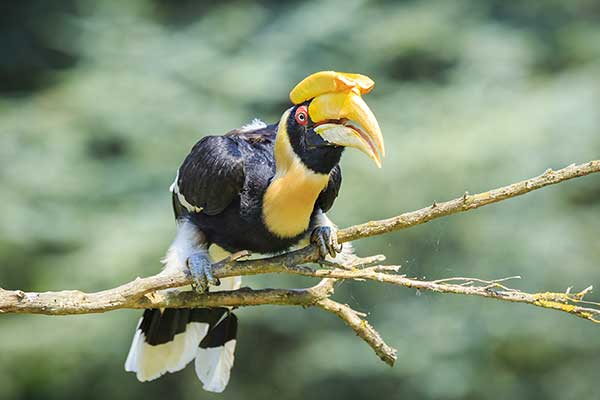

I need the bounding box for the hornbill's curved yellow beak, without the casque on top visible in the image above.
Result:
[308,87,385,168]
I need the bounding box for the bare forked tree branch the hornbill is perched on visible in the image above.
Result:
[0,160,600,365]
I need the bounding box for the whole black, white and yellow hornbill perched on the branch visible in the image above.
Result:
[125,71,385,392]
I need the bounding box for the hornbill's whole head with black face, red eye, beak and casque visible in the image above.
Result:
[280,71,385,173]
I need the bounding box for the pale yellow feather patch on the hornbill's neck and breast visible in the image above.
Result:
[263,110,329,238]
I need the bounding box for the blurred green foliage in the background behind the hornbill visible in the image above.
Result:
[0,0,600,400]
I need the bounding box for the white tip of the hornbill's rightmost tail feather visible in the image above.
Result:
[195,339,236,393]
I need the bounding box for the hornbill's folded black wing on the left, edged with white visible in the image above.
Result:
[171,136,245,217]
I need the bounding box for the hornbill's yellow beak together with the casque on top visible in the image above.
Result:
[290,71,385,168]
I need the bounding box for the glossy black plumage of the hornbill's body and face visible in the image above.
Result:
[173,116,342,253]
